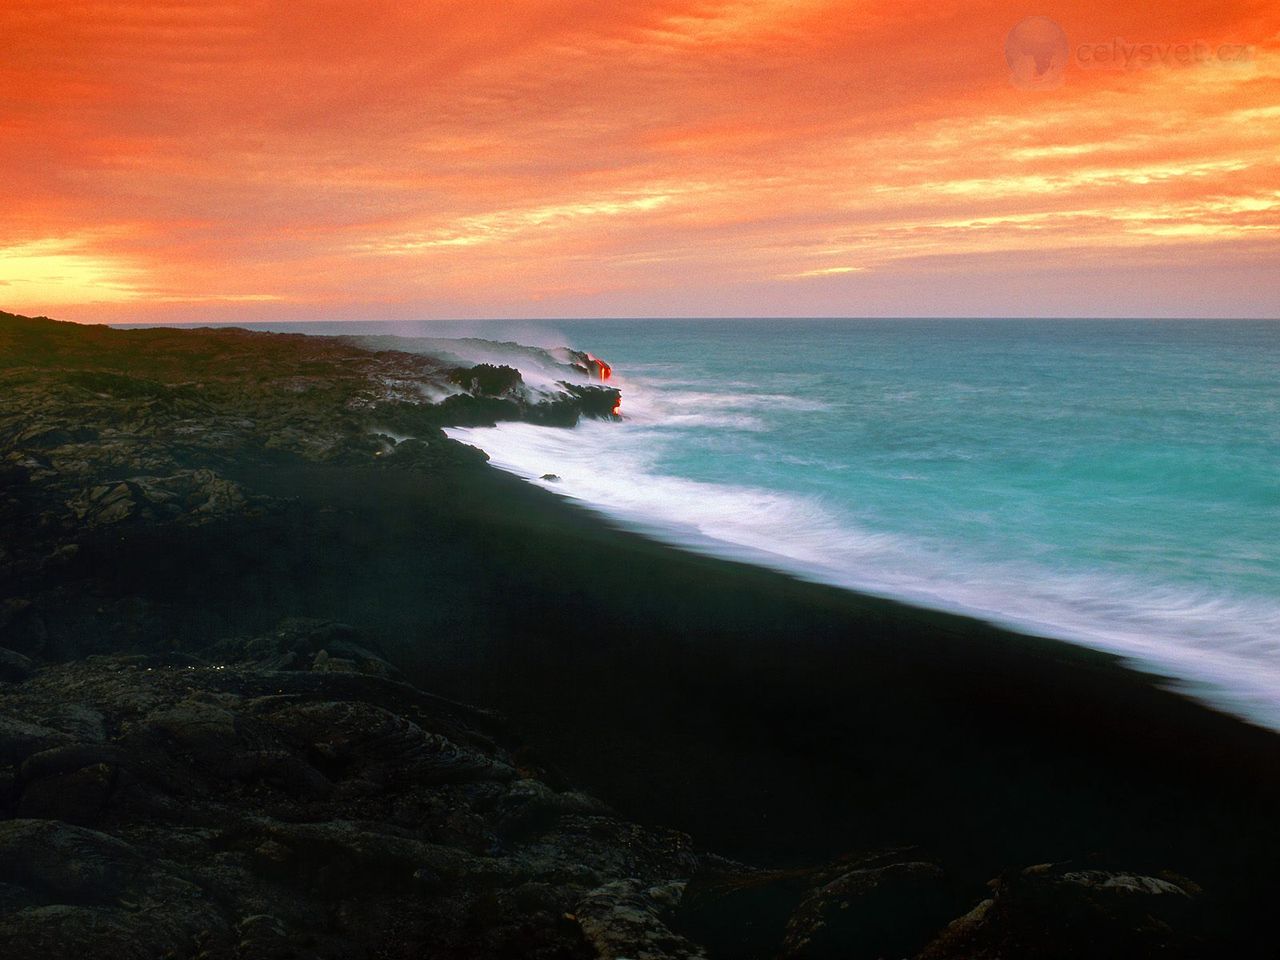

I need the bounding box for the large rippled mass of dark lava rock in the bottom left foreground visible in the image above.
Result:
[0,647,700,960]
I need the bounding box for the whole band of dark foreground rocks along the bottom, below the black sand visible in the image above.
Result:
[0,647,1204,960]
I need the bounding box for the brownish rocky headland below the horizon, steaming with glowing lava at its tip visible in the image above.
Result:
[0,314,621,535]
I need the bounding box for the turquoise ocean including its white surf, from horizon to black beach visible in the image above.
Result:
[249,319,1280,730]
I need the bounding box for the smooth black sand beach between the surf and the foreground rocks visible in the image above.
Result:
[8,313,1280,956]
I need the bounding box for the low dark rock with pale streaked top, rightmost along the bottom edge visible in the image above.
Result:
[919,864,1208,960]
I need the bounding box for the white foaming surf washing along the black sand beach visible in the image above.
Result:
[447,366,1280,730]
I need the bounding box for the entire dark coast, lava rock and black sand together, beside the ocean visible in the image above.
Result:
[0,314,1280,960]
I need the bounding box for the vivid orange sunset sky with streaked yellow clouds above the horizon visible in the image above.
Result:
[0,0,1280,321]
